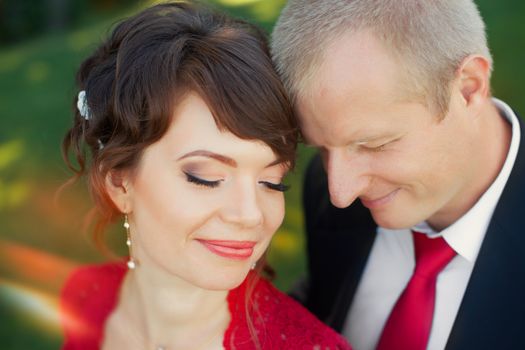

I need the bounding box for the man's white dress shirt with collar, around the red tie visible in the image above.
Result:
[343,99,520,350]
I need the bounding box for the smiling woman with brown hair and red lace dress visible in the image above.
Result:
[61,3,348,349]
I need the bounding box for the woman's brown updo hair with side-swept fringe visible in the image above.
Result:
[63,2,297,239]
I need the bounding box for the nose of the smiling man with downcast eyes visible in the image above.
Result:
[324,151,369,208]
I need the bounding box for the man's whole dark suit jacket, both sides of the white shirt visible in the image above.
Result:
[303,117,525,350]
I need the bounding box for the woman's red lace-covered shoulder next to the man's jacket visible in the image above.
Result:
[227,278,351,350]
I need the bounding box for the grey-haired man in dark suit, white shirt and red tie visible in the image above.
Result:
[272,0,525,350]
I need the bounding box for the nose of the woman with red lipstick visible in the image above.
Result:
[222,184,263,228]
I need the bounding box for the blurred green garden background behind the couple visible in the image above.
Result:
[0,0,525,349]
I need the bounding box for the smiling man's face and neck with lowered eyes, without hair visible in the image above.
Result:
[296,33,476,229]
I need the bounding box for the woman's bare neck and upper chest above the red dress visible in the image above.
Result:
[115,263,230,350]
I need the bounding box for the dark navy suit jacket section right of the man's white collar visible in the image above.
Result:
[446,117,525,350]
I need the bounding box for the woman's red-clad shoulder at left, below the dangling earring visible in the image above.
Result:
[60,262,126,349]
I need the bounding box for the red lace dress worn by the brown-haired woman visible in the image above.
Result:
[60,264,351,350]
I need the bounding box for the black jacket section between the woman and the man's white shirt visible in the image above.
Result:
[303,156,377,332]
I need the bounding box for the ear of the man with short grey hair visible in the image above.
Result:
[457,55,490,109]
